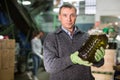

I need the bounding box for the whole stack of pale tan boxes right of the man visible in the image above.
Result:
[91,49,116,80]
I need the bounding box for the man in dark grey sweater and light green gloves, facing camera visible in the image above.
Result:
[43,4,105,80]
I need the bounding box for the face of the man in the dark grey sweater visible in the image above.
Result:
[59,7,76,30]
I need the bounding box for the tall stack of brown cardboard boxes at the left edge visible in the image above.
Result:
[0,39,15,80]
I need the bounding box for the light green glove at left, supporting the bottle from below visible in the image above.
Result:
[70,51,92,66]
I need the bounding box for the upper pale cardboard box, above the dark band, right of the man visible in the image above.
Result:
[91,49,116,73]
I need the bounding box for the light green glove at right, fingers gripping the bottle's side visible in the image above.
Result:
[95,47,105,62]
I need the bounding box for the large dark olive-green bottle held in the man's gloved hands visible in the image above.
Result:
[78,34,108,62]
